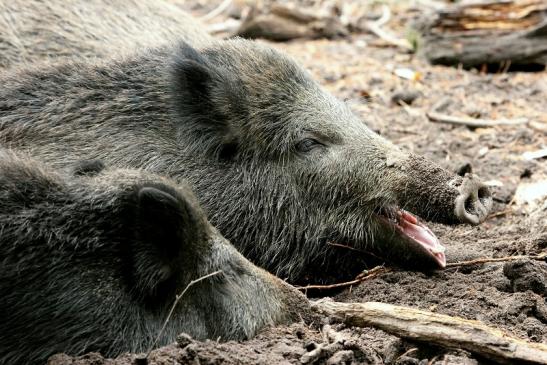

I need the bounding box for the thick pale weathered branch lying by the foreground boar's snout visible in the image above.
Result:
[311,299,547,364]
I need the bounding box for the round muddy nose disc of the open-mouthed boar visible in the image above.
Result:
[454,173,492,224]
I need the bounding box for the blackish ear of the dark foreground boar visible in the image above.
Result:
[130,185,204,298]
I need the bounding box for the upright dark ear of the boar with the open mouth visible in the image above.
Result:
[172,44,242,160]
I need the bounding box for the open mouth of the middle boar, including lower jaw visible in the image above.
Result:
[377,207,446,268]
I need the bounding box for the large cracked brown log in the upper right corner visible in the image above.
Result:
[417,0,547,68]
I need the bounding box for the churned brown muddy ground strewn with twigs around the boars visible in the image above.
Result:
[50,1,547,365]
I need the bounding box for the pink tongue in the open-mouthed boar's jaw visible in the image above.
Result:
[398,210,446,267]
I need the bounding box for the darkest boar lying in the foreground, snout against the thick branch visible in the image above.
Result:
[0,149,309,364]
